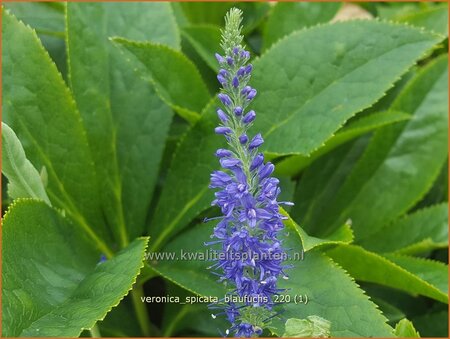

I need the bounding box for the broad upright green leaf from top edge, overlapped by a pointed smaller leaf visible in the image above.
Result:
[67,3,179,245]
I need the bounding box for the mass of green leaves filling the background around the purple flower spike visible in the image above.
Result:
[2,2,448,337]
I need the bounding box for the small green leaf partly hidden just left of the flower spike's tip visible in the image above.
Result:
[181,25,221,72]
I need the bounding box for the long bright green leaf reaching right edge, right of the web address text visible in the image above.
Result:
[327,245,448,303]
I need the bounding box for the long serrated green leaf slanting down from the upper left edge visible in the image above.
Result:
[2,12,109,252]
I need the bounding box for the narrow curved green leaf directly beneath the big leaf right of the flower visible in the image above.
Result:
[276,111,410,176]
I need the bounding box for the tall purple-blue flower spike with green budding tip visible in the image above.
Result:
[207,8,289,337]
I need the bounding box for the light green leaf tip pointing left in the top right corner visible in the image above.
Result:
[382,4,448,36]
